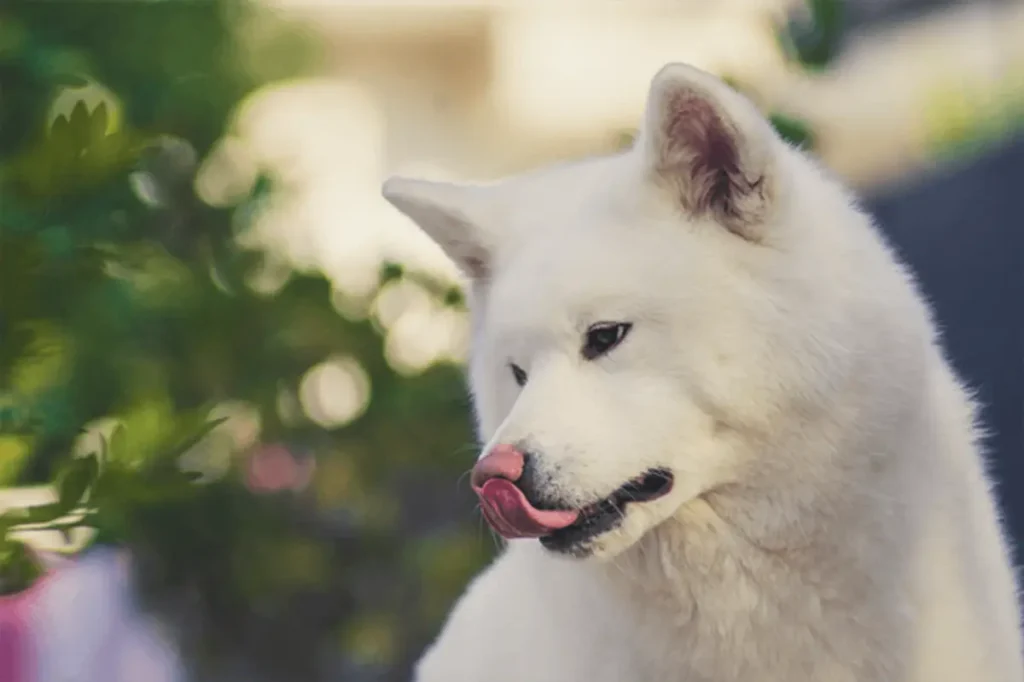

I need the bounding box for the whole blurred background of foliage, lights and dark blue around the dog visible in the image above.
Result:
[0,0,1024,682]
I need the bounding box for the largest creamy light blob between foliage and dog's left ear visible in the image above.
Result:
[226,79,414,299]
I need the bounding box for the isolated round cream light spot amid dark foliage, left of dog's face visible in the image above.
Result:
[299,357,370,429]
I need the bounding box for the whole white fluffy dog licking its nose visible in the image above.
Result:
[384,65,1024,682]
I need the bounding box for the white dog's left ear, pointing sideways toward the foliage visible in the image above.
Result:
[382,177,494,281]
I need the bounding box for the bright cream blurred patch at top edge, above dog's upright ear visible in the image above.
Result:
[494,8,782,138]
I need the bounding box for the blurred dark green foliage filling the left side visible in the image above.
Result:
[0,0,483,680]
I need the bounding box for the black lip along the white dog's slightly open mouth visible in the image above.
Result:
[541,469,673,556]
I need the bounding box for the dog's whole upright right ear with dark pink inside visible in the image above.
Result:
[638,63,779,241]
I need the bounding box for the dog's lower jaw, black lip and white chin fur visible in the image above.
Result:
[540,469,673,560]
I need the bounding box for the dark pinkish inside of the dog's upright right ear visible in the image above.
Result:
[657,90,763,224]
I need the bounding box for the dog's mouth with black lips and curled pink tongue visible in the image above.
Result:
[476,469,673,553]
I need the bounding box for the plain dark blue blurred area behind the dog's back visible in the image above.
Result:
[866,138,1024,559]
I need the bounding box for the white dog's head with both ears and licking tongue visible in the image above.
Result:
[384,65,921,557]
